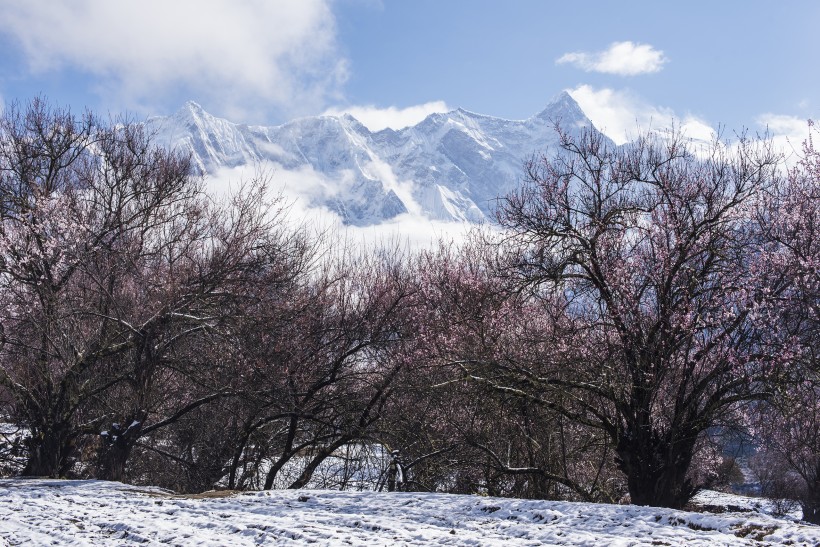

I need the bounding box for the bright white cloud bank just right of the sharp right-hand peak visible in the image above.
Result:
[567,85,715,144]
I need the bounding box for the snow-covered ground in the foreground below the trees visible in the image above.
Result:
[0,479,820,547]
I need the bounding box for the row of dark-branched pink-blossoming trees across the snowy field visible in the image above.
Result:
[0,100,820,522]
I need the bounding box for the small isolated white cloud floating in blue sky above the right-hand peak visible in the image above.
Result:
[555,42,668,76]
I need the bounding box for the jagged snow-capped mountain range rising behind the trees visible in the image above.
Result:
[148,92,592,226]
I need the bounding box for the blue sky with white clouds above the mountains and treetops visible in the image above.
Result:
[0,0,820,144]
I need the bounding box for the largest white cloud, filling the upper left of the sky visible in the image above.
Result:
[0,0,347,122]
